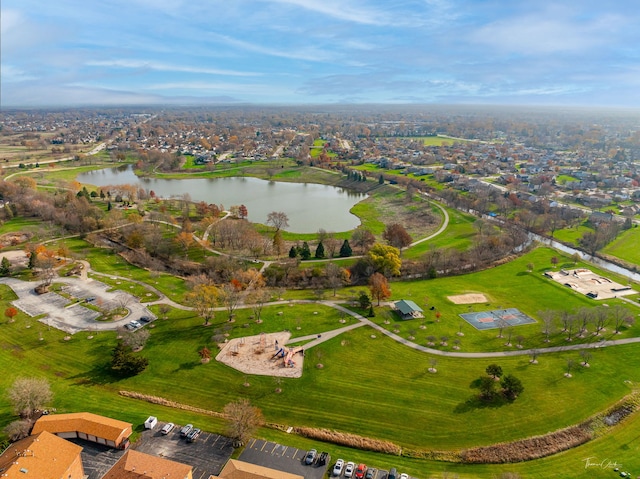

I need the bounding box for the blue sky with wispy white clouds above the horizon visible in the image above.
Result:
[0,0,640,107]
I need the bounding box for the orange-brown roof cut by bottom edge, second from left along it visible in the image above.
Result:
[102,450,192,479]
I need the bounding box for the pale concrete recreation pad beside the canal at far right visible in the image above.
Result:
[544,268,638,299]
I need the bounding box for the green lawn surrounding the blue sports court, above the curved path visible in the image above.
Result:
[372,247,640,352]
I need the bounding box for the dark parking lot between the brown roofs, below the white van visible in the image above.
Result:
[133,422,233,479]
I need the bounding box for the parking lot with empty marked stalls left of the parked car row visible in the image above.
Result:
[239,439,329,479]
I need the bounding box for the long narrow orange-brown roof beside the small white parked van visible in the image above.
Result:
[33,412,133,445]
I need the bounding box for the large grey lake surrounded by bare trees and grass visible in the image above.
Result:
[76,166,367,233]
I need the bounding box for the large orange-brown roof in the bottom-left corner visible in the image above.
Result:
[0,431,82,479]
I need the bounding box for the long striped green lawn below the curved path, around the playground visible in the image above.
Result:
[0,305,640,456]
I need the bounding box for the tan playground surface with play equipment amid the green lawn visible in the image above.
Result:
[216,331,304,378]
